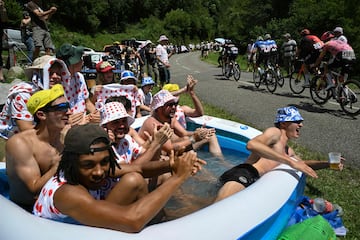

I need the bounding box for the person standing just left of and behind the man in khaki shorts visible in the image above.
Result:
[20,11,35,65]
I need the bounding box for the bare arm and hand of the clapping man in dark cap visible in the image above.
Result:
[54,152,197,232]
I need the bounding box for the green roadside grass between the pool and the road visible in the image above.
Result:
[198,53,360,240]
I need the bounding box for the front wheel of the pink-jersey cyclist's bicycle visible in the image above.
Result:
[310,76,332,105]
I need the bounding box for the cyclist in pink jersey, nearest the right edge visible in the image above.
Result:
[314,31,355,90]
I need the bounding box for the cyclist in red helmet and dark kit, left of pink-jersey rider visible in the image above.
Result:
[296,28,324,87]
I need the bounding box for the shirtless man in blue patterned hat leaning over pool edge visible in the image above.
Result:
[215,106,343,202]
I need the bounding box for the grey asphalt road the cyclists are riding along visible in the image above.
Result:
[170,52,360,167]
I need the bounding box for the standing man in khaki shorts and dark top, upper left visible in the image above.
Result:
[26,0,57,60]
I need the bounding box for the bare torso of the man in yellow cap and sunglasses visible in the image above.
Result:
[6,129,60,207]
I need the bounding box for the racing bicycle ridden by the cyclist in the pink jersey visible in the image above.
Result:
[310,63,360,116]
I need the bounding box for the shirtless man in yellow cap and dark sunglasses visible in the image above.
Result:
[6,84,71,212]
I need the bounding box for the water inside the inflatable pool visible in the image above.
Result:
[164,149,248,220]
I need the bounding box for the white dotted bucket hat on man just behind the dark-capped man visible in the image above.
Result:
[101,102,135,126]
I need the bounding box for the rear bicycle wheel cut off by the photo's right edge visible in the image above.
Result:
[339,80,360,116]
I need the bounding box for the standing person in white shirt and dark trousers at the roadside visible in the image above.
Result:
[156,35,174,87]
